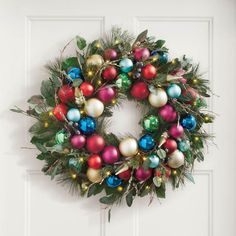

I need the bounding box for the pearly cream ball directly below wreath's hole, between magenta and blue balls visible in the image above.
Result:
[119,138,138,157]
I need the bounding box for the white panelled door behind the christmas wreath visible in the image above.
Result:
[0,0,236,236]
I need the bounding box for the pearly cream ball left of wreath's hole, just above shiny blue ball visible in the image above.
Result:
[84,98,104,117]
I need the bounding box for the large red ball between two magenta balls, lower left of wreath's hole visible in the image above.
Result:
[86,134,105,153]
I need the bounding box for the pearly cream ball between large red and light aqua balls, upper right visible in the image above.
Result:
[148,88,168,107]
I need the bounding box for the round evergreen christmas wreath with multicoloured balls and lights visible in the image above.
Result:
[12,28,213,206]
